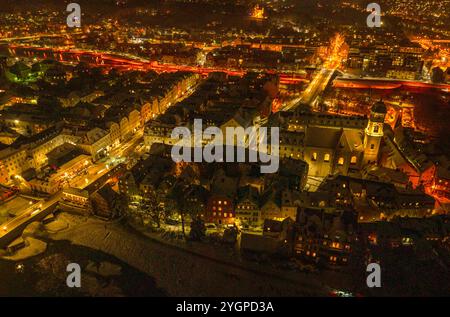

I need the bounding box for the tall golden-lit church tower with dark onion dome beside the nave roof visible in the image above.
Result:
[362,100,387,165]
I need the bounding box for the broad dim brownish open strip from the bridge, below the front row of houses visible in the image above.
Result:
[50,215,327,296]
